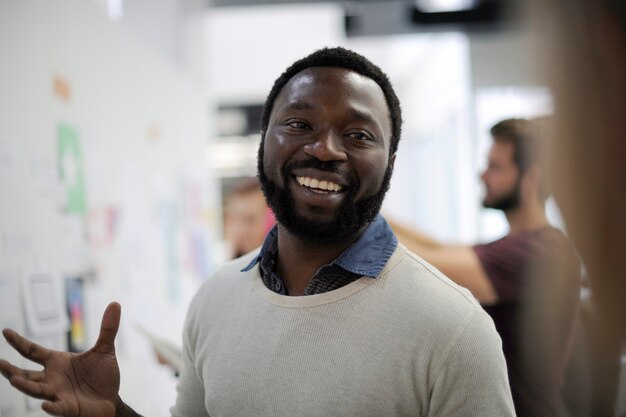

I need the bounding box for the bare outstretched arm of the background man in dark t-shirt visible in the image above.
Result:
[389,221,498,305]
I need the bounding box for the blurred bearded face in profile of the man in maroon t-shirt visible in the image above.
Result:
[481,141,520,211]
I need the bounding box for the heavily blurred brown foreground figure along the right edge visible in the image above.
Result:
[531,0,626,416]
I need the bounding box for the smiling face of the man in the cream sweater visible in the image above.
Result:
[259,67,393,242]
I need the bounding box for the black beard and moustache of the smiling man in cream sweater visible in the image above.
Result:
[257,142,393,243]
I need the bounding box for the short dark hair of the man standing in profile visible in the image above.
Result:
[489,117,550,200]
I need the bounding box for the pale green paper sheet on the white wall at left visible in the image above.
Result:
[57,123,87,215]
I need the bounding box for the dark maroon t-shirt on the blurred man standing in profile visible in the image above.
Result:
[474,227,580,417]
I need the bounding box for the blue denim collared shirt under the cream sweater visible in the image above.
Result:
[242,214,398,295]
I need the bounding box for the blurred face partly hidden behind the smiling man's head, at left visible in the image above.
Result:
[224,177,276,259]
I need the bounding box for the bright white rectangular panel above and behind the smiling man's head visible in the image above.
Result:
[205,4,344,103]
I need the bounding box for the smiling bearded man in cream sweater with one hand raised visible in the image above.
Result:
[0,48,514,417]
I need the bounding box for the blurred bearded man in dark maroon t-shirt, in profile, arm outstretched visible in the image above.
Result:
[392,119,580,417]
